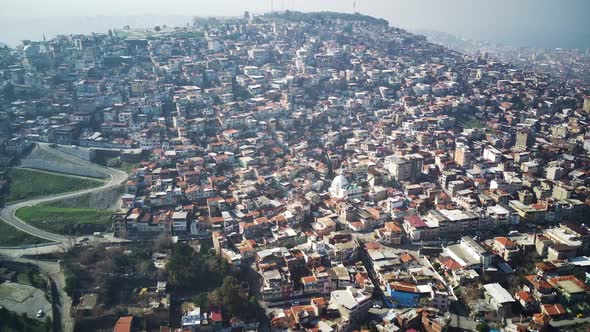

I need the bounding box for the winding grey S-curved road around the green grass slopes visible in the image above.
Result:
[0,143,127,245]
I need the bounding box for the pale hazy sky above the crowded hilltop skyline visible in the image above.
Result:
[0,0,590,48]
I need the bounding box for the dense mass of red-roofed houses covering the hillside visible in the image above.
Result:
[0,9,590,331]
